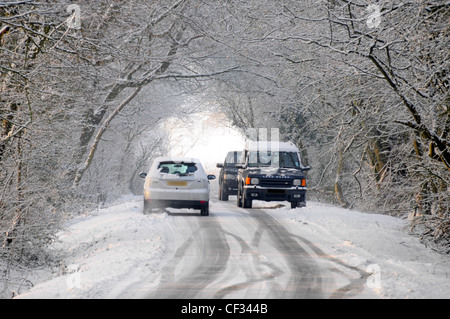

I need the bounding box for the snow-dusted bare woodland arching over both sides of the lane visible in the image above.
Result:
[0,0,450,292]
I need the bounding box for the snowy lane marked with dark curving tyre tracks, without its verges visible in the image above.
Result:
[128,201,377,299]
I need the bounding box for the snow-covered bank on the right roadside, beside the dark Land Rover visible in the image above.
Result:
[273,203,450,299]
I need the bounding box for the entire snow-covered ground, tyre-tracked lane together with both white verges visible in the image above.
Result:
[14,197,450,299]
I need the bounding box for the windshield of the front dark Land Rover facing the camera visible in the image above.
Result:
[248,151,300,169]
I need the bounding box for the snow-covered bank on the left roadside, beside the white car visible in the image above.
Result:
[15,197,167,299]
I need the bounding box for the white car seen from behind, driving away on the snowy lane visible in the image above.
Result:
[139,157,216,216]
